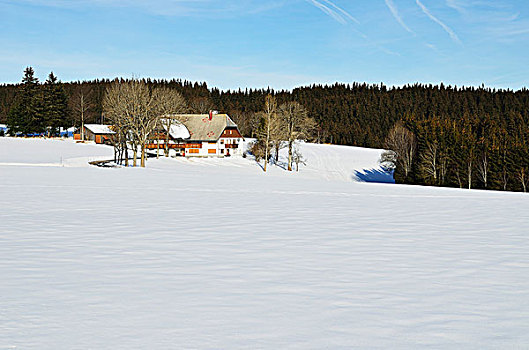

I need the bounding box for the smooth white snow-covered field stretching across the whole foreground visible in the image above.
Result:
[0,138,529,350]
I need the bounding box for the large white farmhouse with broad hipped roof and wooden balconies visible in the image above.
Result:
[147,113,244,157]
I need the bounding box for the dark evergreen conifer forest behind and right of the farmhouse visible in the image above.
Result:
[0,70,529,191]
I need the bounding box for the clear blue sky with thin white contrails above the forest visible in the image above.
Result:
[0,0,529,89]
